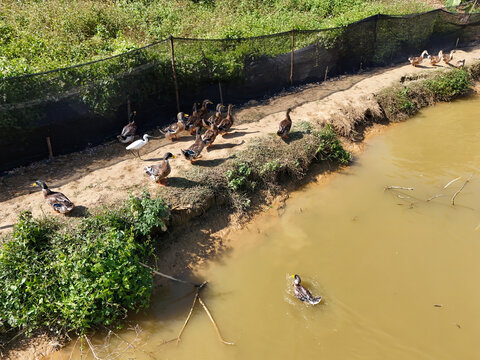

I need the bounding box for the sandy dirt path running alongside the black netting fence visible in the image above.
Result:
[0,47,480,234]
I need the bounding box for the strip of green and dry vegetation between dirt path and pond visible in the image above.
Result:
[0,52,480,354]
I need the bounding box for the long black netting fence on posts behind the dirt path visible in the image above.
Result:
[0,10,480,171]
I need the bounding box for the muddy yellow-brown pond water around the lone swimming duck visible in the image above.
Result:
[51,97,480,360]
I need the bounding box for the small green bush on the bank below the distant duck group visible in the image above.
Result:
[424,70,471,100]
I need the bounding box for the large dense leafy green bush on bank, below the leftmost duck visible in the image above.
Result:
[0,192,169,333]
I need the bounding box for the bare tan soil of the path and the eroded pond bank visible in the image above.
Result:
[0,47,480,360]
